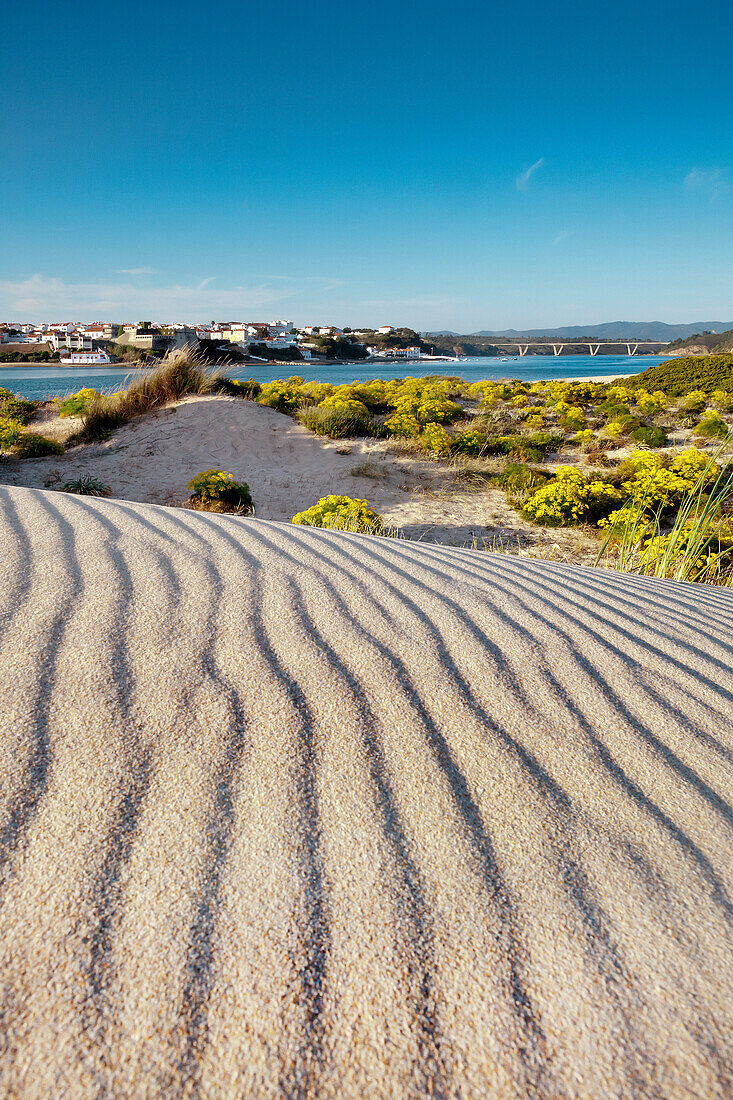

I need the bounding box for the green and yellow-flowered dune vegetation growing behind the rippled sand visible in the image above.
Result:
[0,350,733,584]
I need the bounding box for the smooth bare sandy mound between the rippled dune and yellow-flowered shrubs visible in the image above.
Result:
[0,397,557,546]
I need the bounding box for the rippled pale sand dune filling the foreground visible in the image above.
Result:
[0,487,733,1100]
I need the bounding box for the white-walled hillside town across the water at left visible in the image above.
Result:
[0,319,424,364]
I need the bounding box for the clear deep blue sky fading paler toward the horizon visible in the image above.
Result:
[0,0,733,331]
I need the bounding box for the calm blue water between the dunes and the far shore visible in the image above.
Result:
[0,355,666,400]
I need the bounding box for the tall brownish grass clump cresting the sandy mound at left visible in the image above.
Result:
[74,348,222,442]
